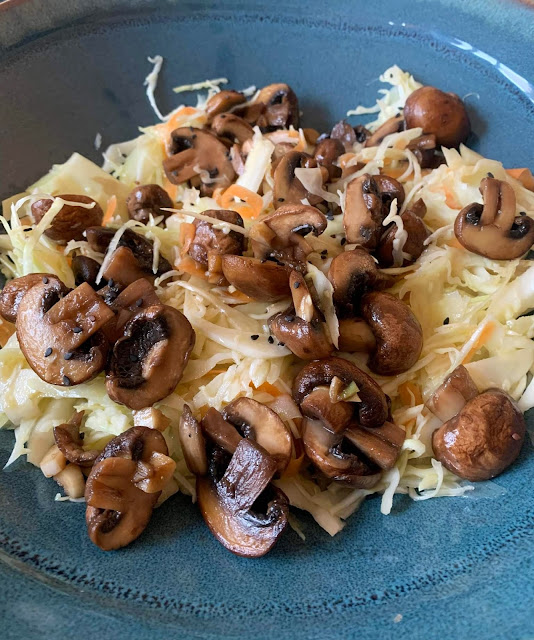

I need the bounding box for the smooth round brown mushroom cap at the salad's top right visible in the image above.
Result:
[404,86,471,147]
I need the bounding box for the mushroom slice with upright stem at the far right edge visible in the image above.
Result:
[454,178,534,260]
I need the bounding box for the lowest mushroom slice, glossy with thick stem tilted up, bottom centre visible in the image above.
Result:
[197,438,289,558]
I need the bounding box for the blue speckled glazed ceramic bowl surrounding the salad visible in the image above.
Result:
[0,0,534,640]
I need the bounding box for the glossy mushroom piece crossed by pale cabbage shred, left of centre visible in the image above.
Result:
[186,209,245,284]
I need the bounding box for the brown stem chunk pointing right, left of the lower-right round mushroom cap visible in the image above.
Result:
[343,421,406,471]
